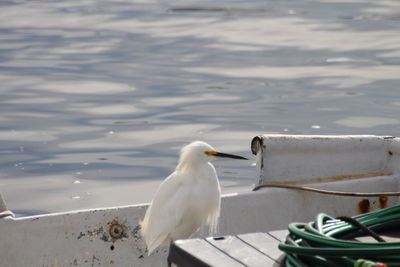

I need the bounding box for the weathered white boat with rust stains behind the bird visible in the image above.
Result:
[0,135,400,267]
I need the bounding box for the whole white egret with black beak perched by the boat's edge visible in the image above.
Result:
[141,141,246,255]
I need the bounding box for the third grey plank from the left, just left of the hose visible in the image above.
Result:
[238,233,283,263]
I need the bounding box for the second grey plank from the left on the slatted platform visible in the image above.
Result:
[206,236,274,266]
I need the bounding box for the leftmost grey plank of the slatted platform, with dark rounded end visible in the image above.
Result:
[168,238,245,267]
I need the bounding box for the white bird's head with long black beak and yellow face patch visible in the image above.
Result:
[179,141,247,171]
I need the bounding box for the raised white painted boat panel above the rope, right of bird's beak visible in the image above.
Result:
[250,135,400,183]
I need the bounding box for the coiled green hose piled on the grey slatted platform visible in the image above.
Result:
[279,206,400,267]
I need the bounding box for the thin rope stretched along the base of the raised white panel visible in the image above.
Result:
[253,182,400,197]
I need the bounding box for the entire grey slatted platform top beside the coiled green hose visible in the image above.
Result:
[169,230,287,267]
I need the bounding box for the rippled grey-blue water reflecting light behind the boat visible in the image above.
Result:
[0,0,400,217]
